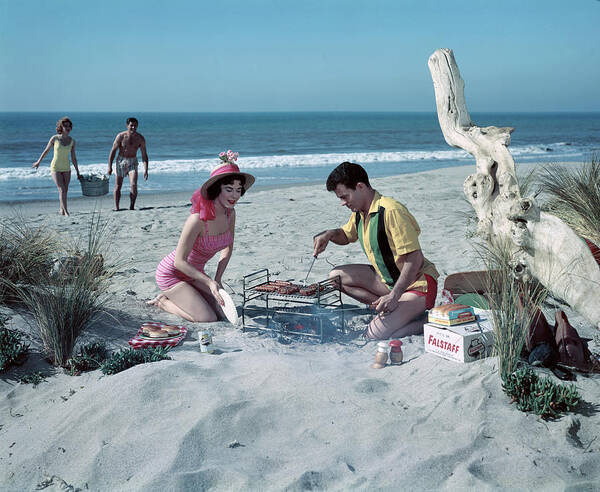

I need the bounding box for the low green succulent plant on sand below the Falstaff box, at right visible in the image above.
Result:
[502,368,581,419]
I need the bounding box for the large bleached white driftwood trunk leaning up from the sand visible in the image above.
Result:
[429,49,600,328]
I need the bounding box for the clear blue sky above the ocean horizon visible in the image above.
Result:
[0,0,600,112]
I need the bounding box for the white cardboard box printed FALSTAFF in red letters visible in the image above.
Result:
[424,315,494,362]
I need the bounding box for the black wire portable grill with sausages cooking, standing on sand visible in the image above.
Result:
[242,268,345,341]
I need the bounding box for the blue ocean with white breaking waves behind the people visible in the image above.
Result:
[0,112,600,201]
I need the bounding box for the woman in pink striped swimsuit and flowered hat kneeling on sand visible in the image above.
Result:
[149,150,254,322]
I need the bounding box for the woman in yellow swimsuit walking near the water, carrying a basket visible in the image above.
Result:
[31,116,81,215]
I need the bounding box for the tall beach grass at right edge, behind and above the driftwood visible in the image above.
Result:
[539,157,600,245]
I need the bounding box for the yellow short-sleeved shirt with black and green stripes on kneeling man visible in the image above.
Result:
[342,191,439,292]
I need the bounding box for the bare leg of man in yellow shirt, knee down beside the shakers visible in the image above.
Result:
[365,292,425,340]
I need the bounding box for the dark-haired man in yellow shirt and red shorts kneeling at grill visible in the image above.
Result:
[313,162,439,339]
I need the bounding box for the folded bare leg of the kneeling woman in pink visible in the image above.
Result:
[150,282,217,323]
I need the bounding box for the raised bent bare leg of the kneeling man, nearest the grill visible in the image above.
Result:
[329,264,390,304]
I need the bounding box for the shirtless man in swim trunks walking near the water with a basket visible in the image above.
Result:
[108,118,148,211]
